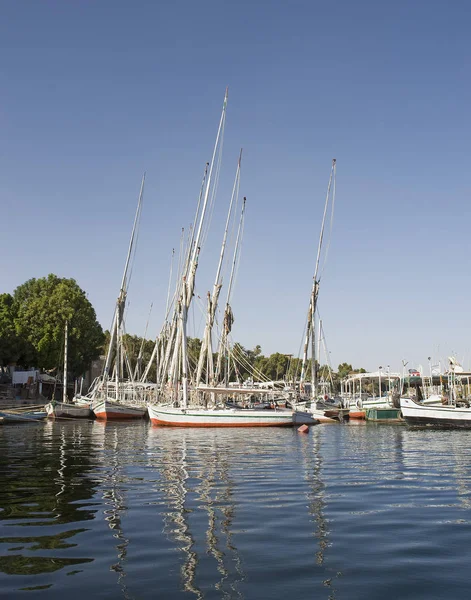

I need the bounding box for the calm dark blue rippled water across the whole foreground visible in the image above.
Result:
[0,422,471,600]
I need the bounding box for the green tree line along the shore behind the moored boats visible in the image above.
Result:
[0,274,365,383]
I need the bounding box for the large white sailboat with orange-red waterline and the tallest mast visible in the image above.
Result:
[148,90,317,427]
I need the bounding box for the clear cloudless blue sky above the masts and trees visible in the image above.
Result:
[0,0,471,370]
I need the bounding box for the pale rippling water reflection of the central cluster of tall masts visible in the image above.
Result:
[149,429,245,598]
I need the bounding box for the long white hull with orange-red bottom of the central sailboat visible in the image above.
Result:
[148,405,317,427]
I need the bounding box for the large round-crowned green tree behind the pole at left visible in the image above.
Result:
[13,274,104,376]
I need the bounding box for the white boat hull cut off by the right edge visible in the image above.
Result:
[401,398,471,429]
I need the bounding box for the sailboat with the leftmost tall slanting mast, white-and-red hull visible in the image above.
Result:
[92,175,148,420]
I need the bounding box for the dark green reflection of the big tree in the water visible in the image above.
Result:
[0,423,95,587]
